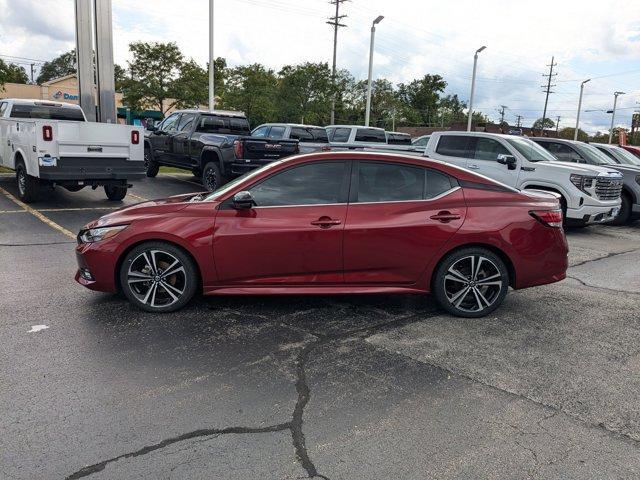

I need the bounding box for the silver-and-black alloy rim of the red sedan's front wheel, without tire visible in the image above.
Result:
[127,250,188,308]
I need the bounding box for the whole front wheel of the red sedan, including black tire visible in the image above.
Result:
[118,242,198,312]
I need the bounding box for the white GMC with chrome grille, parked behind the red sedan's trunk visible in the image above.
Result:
[425,132,622,226]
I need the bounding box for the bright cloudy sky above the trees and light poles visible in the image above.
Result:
[0,0,640,133]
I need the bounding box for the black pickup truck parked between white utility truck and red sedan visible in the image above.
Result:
[144,110,298,191]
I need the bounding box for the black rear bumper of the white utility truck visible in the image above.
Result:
[39,157,145,183]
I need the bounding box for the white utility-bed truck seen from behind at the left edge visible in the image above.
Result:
[0,98,144,203]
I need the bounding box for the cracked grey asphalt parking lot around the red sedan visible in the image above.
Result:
[0,174,640,479]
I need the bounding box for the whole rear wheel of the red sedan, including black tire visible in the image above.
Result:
[431,247,509,318]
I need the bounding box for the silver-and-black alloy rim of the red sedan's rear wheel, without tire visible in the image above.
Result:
[444,255,503,313]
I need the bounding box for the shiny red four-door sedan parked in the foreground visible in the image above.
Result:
[76,152,568,317]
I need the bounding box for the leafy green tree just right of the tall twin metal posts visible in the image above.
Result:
[123,42,183,113]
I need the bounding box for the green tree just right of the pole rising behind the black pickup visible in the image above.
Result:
[223,63,278,125]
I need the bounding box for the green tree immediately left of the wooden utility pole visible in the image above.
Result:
[276,62,334,125]
